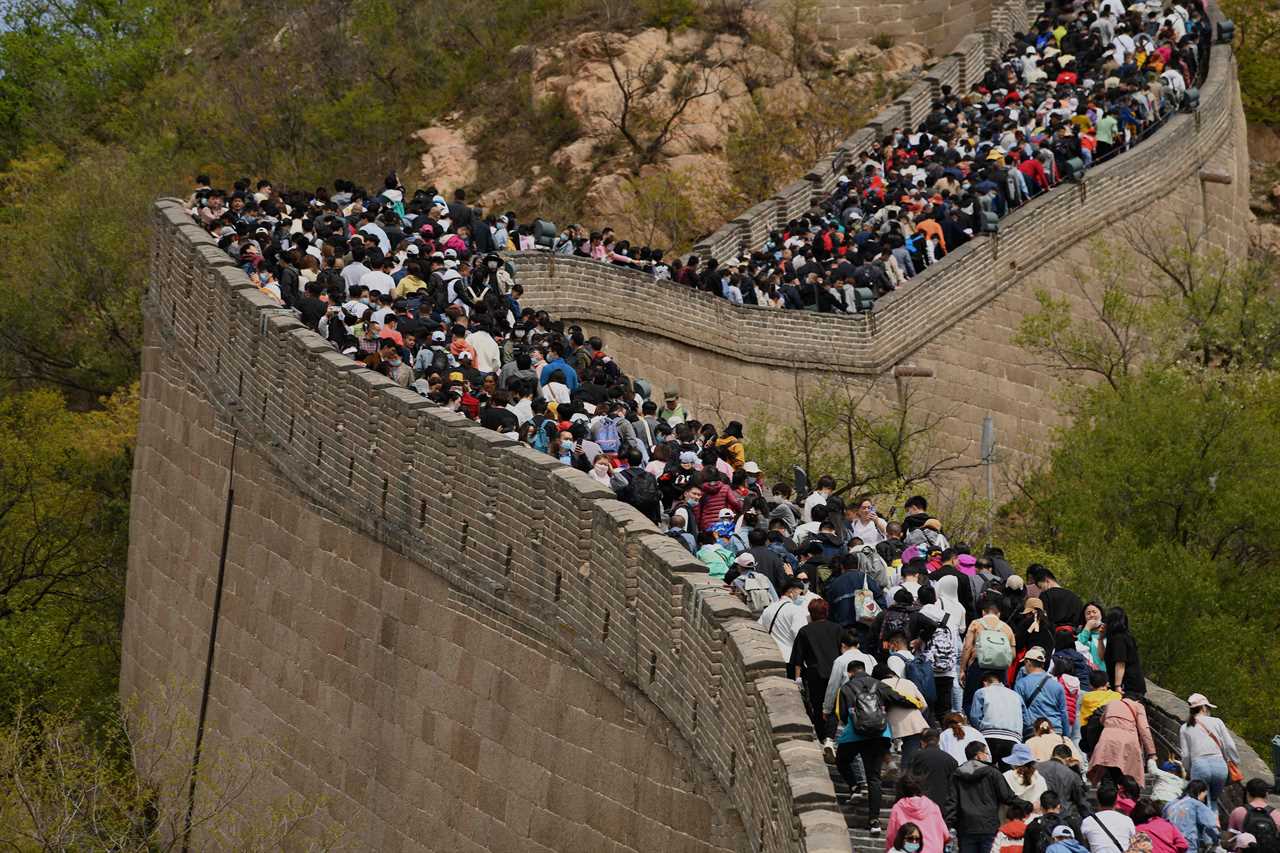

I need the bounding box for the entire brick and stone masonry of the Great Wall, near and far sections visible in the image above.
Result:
[122,4,1265,853]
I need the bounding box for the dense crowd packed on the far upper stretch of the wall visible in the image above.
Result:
[663,0,1212,314]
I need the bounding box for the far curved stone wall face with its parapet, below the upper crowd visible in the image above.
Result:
[515,38,1248,491]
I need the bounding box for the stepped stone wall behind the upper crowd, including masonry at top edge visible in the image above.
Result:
[694,0,1043,261]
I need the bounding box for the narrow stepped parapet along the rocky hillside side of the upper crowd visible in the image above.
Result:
[694,0,1043,263]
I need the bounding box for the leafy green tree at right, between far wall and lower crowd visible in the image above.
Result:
[1009,234,1280,742]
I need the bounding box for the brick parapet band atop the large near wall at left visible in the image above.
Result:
[147,200,850,853]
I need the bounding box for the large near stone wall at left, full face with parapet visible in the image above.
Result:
[122,201,850,852]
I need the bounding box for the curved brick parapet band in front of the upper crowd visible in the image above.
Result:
[512,29,1238,374]
